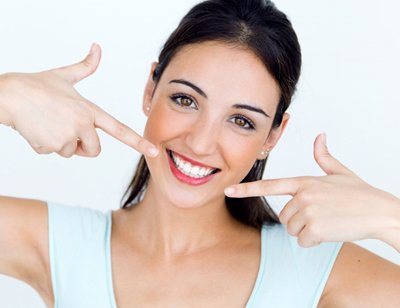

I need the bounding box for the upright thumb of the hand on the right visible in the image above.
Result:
[314,133,354,174]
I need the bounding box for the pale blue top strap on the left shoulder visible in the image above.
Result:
[47,202,113,308]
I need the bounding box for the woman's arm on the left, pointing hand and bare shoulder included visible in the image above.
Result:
[0,45,157,306]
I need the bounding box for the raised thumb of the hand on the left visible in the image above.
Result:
[53,43,101,84]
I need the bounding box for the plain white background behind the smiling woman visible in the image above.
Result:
[0,0,400,308]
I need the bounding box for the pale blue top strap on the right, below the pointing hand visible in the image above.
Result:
[247,224,343,308]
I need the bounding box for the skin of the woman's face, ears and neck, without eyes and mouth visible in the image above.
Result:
[132,43,288,255]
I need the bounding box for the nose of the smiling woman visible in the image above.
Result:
[185,117,220,156]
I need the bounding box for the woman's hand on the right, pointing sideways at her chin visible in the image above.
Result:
[225,134,400,247]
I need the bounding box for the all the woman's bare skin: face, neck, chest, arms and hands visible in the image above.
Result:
[0,43,400,307]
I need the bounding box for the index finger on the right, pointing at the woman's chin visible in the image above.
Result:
[225,177,301,198]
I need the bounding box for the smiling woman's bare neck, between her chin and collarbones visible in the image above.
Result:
[119,181,243,259]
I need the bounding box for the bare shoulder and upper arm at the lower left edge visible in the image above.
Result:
[0,196,52,300]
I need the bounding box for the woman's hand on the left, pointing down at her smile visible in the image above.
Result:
[0,44,158,157]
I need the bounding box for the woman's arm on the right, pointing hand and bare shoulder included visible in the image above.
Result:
[225,137,400,308]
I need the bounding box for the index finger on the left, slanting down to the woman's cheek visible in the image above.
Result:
[92,104,159,157]
